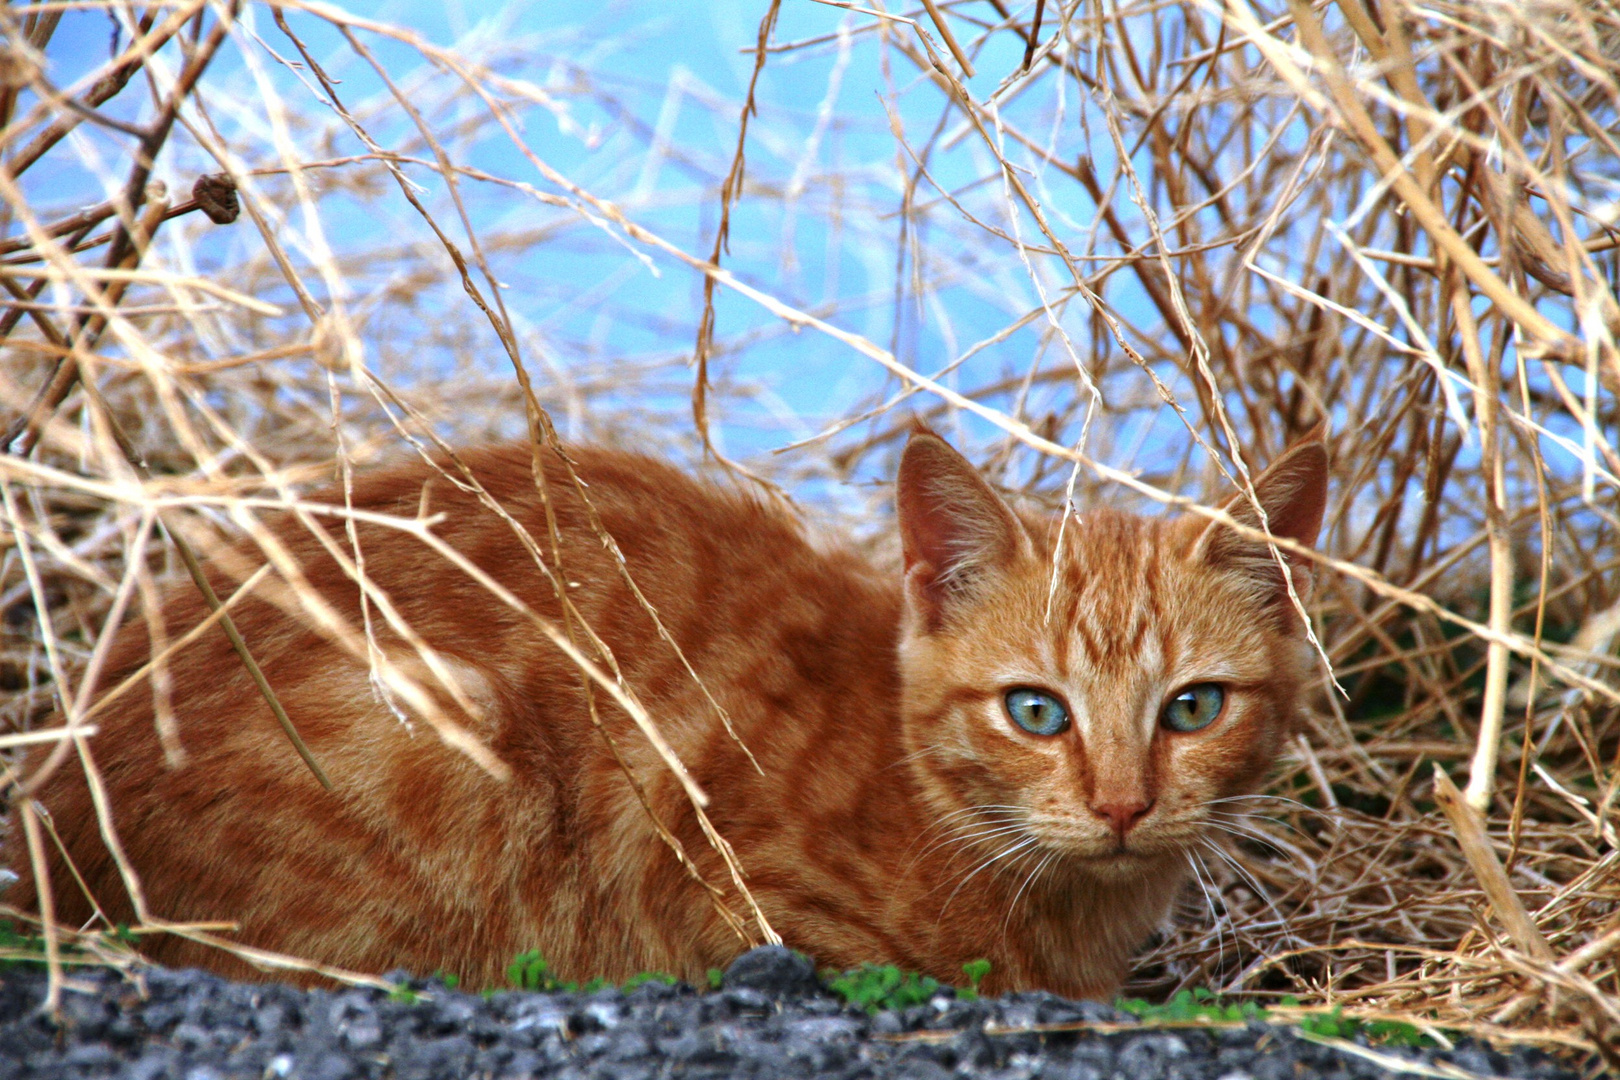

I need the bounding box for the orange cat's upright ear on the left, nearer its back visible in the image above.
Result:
[896,431,1030,630]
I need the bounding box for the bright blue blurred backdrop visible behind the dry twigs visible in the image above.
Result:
[28,0,1237,488]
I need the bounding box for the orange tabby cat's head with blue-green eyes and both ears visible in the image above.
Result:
[897,431,1327,873]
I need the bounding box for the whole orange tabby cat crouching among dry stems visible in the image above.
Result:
[6,432,1327,996]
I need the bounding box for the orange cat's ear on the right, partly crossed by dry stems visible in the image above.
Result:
[1194,432,1327,586]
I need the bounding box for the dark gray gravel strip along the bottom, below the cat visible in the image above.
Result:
[0,950,1580,1080]
